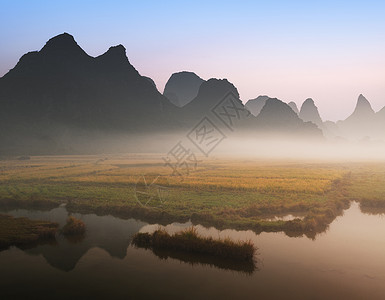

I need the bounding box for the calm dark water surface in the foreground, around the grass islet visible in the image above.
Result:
[0,203,385,299]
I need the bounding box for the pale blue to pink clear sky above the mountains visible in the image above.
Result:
[0,0,385,120]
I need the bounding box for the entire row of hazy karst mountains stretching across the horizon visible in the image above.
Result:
[0,33,385,153]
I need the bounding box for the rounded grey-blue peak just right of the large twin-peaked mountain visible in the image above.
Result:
[163,71,204,107]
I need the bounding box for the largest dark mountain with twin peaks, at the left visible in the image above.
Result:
[0,33,178,152]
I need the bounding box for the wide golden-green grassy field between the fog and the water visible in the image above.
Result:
[0,154,385,237]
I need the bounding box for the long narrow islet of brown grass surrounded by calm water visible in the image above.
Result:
[132,227,256,261]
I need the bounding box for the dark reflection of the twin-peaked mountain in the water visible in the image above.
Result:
[1,206,146,271]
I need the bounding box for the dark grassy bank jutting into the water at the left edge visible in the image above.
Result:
[0,215,58,249]
